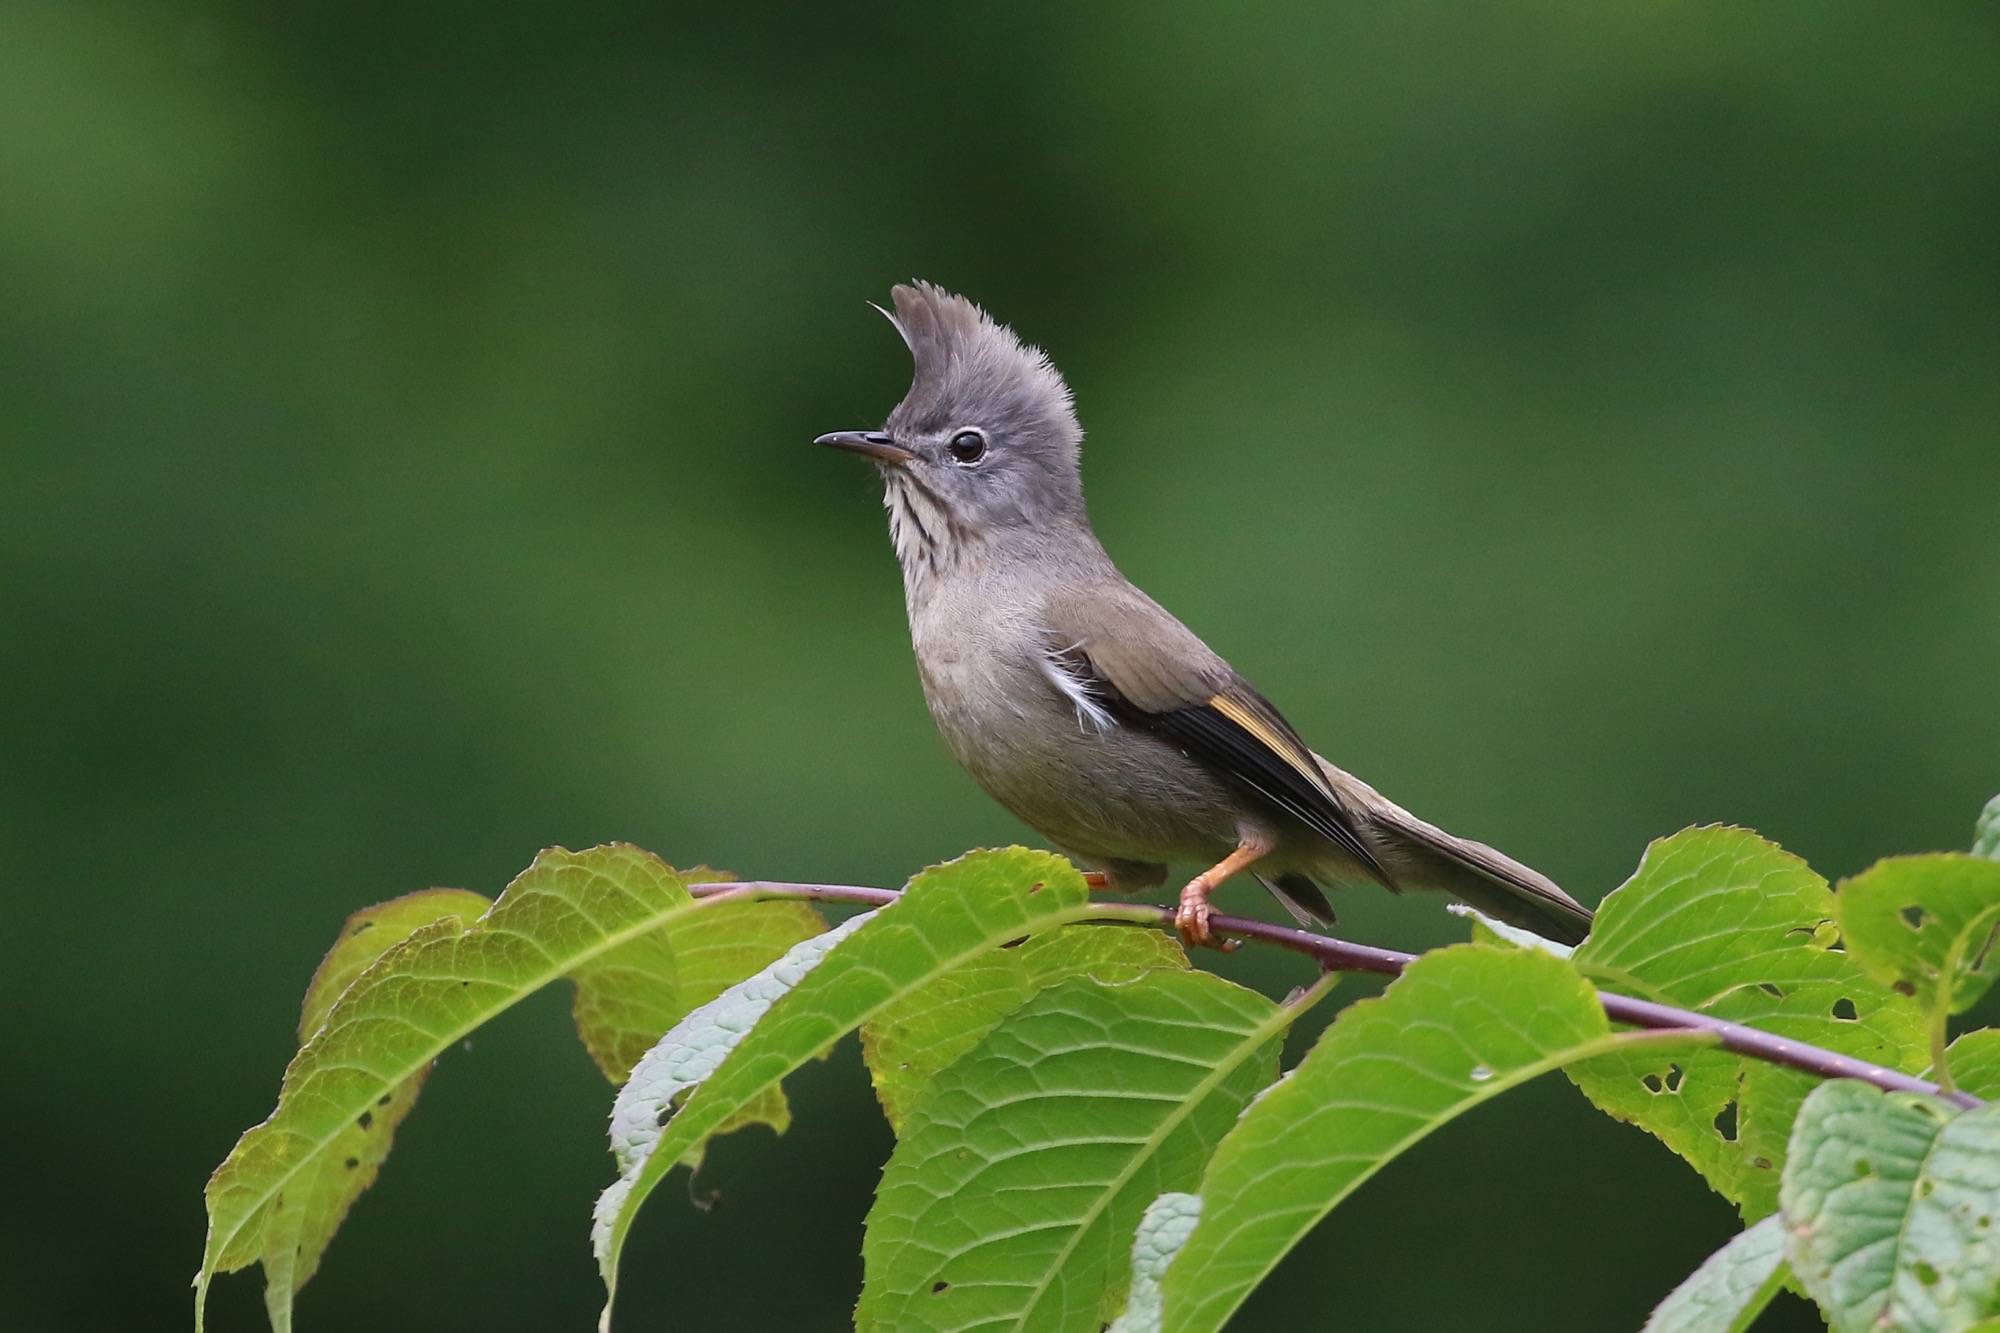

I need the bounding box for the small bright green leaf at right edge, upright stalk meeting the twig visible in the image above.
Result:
[1834,853,2000,1089]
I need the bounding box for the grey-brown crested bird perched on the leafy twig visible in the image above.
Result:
[816,282,1590,945]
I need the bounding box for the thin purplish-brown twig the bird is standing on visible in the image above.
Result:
[708,879,1980,1107]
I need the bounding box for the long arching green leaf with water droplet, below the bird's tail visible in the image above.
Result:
[1164,945,1702,1333]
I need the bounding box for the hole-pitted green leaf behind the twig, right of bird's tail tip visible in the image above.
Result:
[1568,829,1926,1223]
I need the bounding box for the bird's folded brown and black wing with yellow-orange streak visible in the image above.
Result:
[1046,588,1396,889]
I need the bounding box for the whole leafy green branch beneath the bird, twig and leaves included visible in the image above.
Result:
[196,801,2000,1333]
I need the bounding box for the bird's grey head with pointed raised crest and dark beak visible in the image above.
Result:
[818,282,1088,576]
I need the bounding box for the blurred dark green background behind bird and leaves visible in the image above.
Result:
[0,0,2000,1331]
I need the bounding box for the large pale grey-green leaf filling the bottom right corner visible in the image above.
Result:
[1782,1079,2000,1333]
